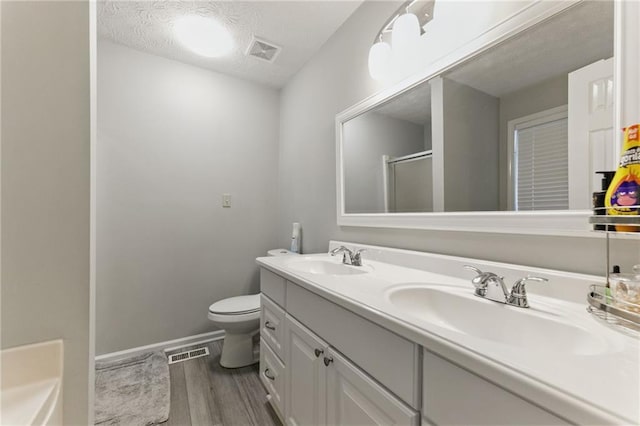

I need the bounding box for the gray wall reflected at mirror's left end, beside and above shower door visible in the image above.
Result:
[343,112,425,213]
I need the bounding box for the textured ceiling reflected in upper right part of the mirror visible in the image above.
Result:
[447,1,613,97]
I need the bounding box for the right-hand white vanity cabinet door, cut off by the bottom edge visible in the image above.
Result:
[327,348,419,426]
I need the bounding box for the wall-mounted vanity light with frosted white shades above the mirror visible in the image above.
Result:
[369,0,435,80]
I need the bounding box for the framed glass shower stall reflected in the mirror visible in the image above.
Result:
[382,150,433,213]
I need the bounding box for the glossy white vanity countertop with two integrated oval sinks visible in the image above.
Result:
[258,248,640,424]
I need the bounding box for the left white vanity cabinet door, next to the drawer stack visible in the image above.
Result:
[284,315,327,426]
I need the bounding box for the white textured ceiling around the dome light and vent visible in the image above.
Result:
[98,0,363,87]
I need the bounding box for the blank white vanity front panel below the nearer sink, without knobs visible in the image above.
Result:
[422,350,568,425]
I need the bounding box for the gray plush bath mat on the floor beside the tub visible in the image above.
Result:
[95,352,170,426]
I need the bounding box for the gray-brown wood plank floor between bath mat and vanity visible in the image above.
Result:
[161,340,280,426]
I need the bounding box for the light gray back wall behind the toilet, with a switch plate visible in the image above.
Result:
[96,41,280,354]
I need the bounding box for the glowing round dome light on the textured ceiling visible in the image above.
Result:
[173,15,234,58]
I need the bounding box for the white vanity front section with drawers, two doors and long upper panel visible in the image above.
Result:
[260,268,420,425]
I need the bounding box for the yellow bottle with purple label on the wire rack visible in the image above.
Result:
[605,124,640,232]
